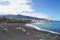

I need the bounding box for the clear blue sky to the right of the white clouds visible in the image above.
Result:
[33,0,60,20]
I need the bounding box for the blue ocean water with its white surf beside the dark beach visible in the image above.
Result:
[28,22,60,34]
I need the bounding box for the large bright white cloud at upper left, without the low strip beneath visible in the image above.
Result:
[0,0,34,14]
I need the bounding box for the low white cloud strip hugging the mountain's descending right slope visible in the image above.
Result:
[21,13,52,20]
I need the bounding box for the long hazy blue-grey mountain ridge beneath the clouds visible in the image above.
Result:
[0,15,48,20]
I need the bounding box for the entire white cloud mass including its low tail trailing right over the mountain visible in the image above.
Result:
[0,0,51,19]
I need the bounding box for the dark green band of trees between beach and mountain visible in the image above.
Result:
[0,17,31,23]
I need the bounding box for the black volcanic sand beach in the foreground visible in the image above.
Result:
[0,23,60,40]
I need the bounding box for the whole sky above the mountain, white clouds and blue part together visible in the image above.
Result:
[0,0,60,21]
